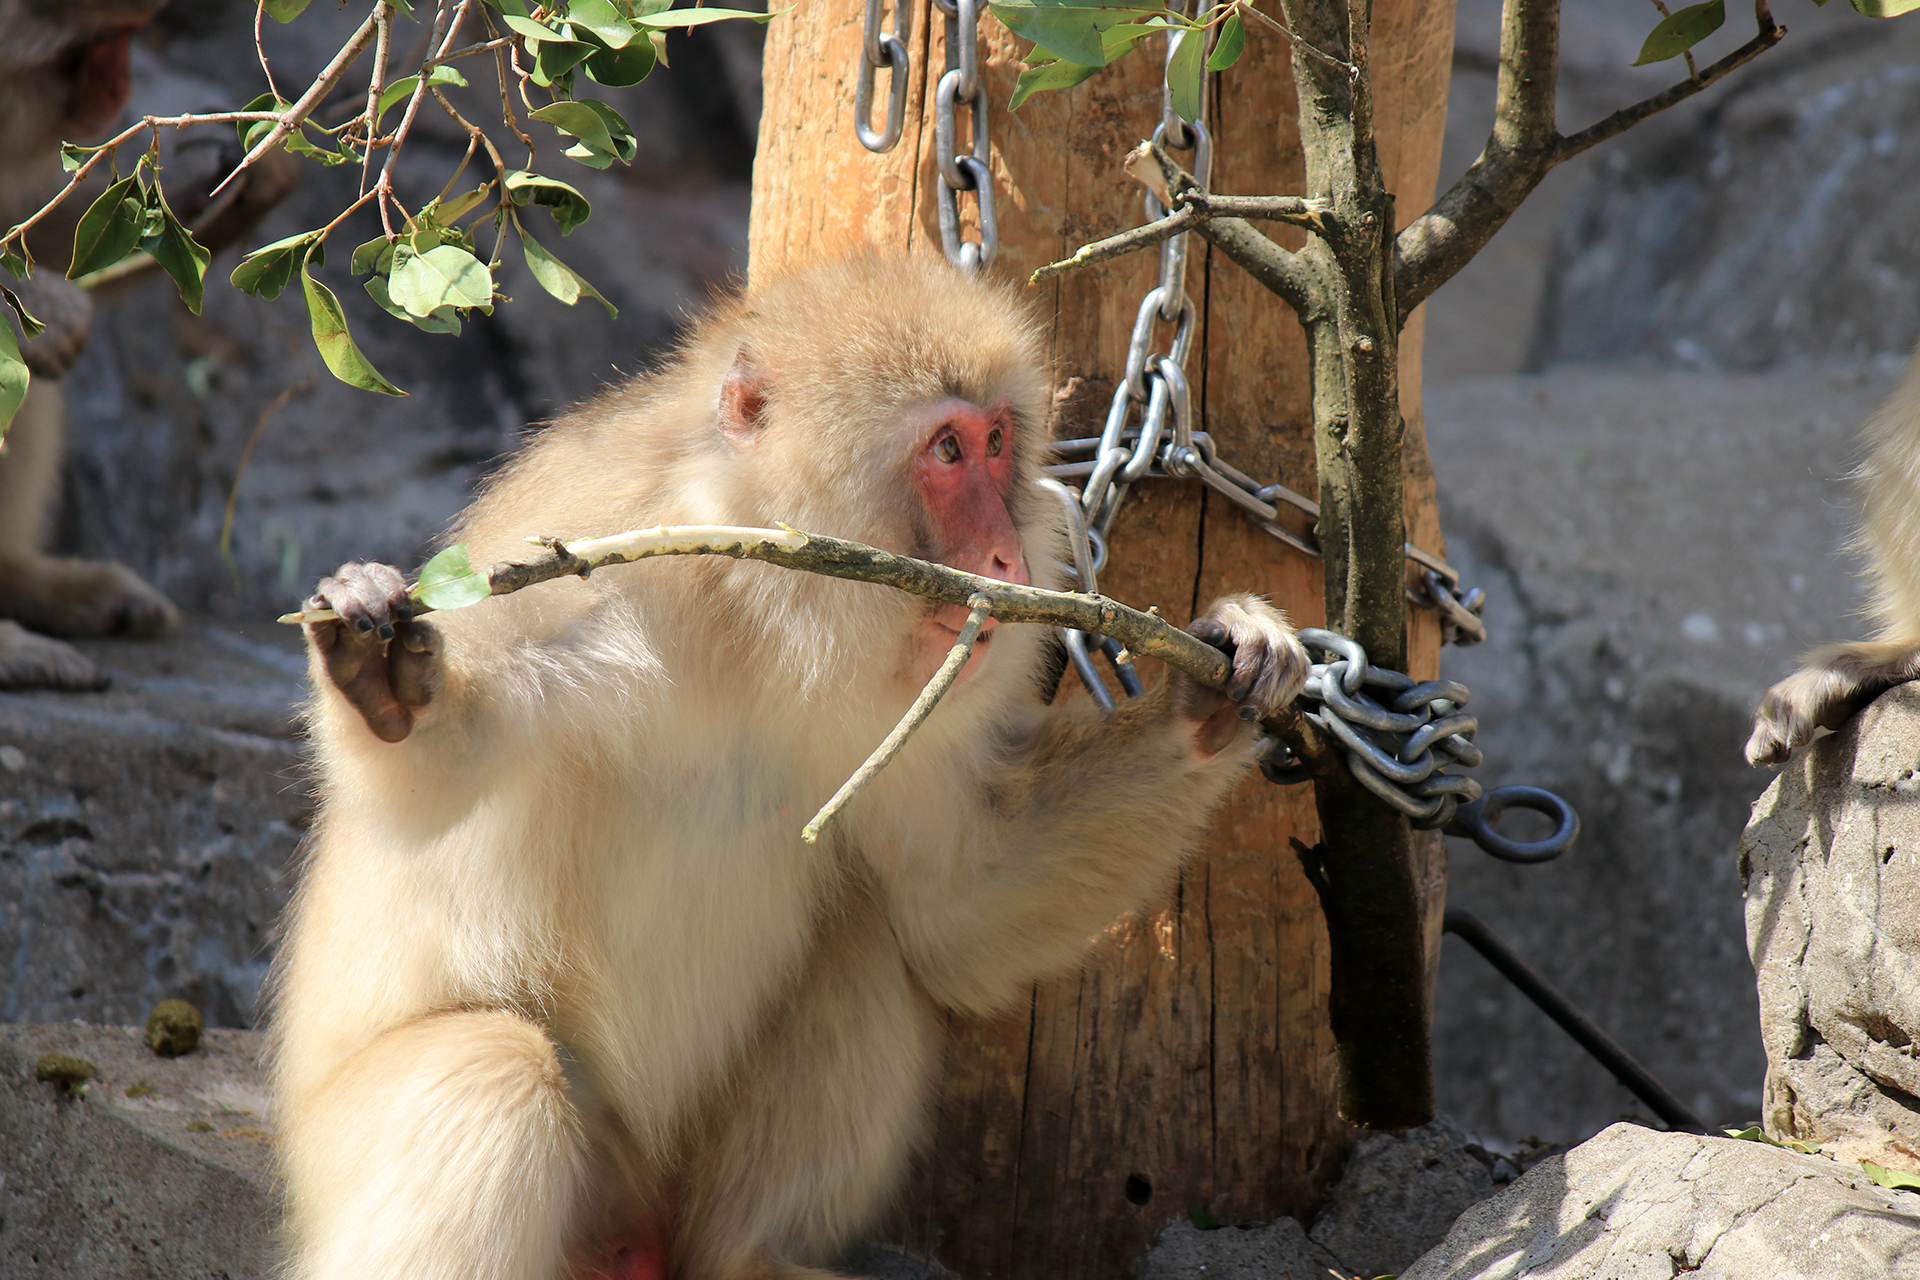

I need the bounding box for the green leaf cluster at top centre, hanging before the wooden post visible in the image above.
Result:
[989,0,1246,121]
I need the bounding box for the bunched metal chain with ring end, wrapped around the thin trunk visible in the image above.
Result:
[1258,628,1580,862]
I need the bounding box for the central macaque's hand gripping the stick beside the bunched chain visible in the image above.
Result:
[1171,595,1309,760]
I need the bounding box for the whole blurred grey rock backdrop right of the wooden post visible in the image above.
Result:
[1427,0,1920,1148]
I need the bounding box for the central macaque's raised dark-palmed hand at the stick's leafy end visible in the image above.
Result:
[307,564,442,743]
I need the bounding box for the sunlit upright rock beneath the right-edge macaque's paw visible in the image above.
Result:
[1740,685,1920,1171]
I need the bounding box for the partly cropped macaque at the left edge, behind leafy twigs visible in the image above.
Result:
[0,0,179,689]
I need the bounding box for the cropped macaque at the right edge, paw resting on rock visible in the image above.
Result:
[1747,357,1920,766]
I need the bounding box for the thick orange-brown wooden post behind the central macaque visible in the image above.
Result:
[751,0,1453,1280]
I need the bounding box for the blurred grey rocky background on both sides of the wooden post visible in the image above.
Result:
[0,0,1920,1150]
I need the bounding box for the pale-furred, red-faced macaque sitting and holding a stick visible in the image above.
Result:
[273,257,1308,1280]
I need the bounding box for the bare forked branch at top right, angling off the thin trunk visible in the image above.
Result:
[1394,0,1786,322]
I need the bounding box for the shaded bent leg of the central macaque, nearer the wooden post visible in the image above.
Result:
[670,890,941,1280]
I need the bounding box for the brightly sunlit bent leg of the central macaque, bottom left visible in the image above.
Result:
[278,1013,586,1280]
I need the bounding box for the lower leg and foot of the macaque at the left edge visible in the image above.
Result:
[0,380,180,644]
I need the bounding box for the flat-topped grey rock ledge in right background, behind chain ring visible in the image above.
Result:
[1427,365,1891,1150]
